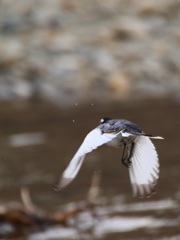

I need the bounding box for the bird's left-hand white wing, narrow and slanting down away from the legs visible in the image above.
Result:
[58,128,119,189]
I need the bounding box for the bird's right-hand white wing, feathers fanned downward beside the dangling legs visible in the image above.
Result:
[129,136,159,197]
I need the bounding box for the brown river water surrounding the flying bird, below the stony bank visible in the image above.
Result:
[0,100,180,239]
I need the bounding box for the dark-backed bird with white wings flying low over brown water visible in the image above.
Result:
[58,117,163,197]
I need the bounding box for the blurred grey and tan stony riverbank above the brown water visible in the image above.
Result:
[0,0,180,106]
